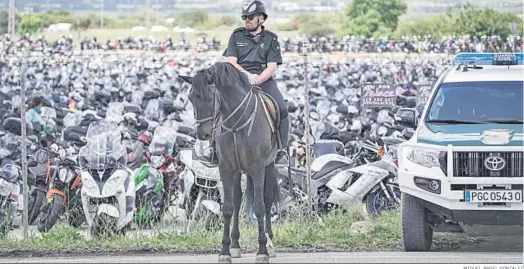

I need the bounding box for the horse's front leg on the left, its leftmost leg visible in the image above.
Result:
[218,169,235,263]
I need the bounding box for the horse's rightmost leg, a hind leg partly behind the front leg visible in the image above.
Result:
[264,164,278,258]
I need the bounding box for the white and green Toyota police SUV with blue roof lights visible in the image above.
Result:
[395,53,524,251]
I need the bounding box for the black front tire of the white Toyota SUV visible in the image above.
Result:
[400,193,433,251]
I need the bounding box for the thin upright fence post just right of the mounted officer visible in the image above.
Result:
[302,49,313,215]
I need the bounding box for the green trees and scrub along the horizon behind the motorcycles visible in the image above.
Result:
[0,0,523,38]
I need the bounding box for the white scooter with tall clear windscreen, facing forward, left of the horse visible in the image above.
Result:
[79,121,135,236]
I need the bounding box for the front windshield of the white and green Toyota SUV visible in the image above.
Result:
[426,81,523,122]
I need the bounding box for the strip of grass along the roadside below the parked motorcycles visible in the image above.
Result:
[0,208,401,254]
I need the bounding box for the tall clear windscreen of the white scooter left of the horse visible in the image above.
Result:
[79,121,126,170]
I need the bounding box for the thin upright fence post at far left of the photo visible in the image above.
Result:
[20,47,29,239]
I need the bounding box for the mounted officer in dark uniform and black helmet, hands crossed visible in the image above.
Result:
[202,0,289,166]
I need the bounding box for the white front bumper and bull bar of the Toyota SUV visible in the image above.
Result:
[398,142,524,216]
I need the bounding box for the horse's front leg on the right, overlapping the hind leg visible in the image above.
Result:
[251,168,269,263]
